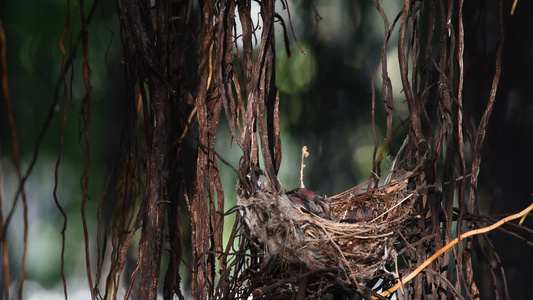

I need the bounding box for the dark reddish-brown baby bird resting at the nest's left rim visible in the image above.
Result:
[286,188,337,221]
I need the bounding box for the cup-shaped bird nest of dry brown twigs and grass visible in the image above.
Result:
[238,176,414,296]
